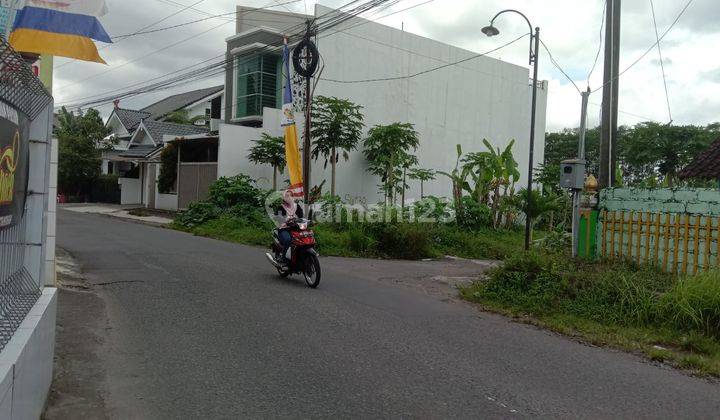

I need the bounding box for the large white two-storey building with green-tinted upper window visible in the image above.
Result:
[218,5,547,203]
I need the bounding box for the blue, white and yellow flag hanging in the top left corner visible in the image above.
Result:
[9,0,112,63]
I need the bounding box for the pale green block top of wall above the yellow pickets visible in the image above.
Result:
[600,188,720,216]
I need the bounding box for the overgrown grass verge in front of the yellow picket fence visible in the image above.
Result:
[461,254,720,377]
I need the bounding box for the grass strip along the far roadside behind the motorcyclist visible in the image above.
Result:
[171,215,523,260]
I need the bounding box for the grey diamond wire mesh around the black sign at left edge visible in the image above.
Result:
[0,38,52,350]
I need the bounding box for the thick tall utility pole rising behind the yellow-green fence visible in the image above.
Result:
[599,0,621,189]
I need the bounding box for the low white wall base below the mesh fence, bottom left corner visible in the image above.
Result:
[0,288,57,420]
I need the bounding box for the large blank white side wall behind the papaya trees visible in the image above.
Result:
[306,6,547,203]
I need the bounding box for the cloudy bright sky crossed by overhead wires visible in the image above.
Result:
[53,0,720,131]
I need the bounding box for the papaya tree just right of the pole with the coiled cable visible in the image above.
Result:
[312,96,365,196]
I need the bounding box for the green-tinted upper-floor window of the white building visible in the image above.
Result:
[234,53,282,118]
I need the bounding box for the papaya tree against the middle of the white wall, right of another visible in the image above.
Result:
[363,123,420,204]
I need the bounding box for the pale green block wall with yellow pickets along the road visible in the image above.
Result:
[597,188,720,274]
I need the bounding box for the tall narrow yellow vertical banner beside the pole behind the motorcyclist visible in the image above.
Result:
[281,38,304,198]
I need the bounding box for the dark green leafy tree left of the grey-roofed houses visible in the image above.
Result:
[55,107,112,195]
